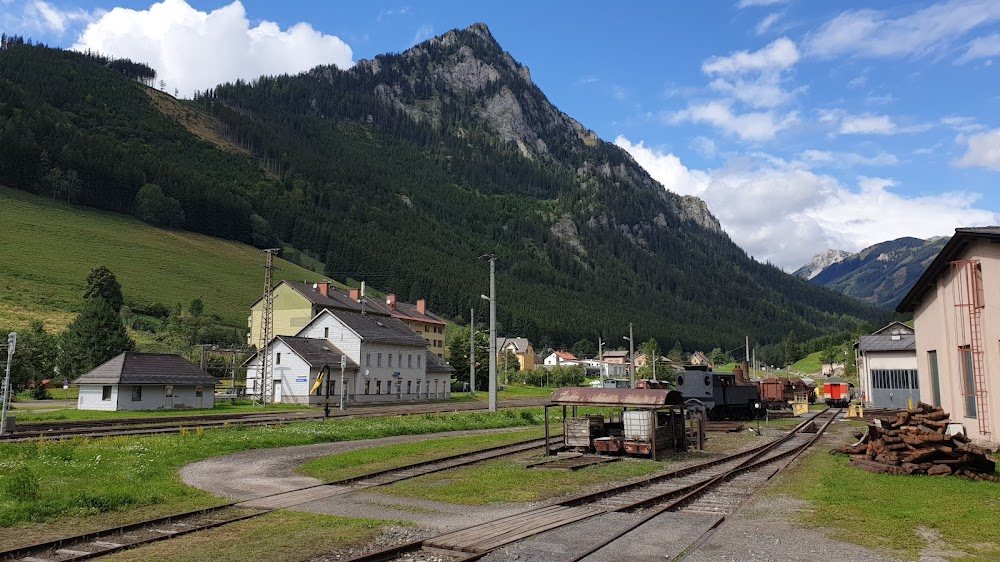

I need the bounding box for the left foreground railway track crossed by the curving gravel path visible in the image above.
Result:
[0,439,545,562]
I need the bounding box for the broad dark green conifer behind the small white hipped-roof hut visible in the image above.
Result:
[59,298,135,378]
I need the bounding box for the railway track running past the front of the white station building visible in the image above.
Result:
[0,398,547,443]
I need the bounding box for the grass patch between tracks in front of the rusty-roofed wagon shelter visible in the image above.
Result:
[378,459,664,505]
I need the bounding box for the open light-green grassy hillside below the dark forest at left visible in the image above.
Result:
[0,187,322,330]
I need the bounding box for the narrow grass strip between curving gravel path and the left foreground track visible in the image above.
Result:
[299,428,558,482]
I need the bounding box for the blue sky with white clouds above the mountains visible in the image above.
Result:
[0,0,1000,269]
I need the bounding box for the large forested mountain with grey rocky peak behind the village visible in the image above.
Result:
[0,29,880,348]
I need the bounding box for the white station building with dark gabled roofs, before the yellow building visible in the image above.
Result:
[246,309,454,404]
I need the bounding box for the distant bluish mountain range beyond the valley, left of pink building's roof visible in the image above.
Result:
[793,236,948,308]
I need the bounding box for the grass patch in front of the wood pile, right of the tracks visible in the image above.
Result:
[769,422,1000,560]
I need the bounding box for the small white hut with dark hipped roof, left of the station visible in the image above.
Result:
[73,351,217,411]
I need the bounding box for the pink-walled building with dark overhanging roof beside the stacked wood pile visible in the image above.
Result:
[896,226,1000,444]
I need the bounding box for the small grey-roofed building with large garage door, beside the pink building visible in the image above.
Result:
[854,322,920,409]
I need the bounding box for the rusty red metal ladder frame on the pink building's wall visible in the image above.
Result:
[951,260,990,435]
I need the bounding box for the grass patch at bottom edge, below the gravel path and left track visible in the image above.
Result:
[105,511,403,562]
